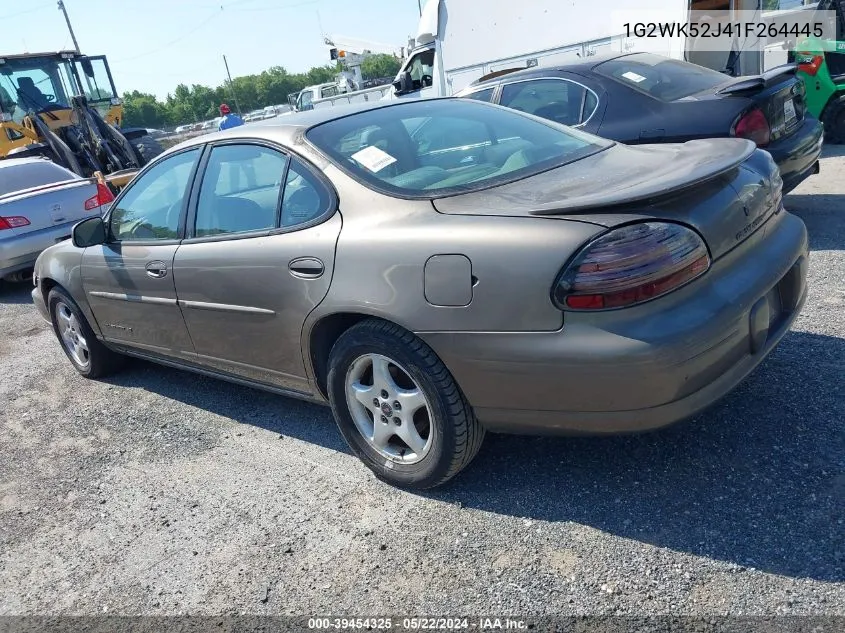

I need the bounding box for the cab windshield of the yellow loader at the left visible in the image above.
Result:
[0,57,74,122]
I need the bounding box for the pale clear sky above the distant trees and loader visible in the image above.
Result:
[0,0,425,98]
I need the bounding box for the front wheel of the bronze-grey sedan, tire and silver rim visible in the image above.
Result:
[47,288,124,378]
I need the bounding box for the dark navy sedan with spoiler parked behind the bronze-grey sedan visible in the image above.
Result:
[459,53,824,193]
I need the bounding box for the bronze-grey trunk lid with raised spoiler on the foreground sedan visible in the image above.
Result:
[432,139,780,259]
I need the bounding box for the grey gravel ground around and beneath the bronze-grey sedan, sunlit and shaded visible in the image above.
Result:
[0,148,845,616]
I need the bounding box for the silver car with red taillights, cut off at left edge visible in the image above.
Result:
[0,157,114,281]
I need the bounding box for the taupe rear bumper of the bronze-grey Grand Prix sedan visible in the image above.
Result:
[420,212,808,434]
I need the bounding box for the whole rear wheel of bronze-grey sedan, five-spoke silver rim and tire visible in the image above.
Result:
[328,319,484,489]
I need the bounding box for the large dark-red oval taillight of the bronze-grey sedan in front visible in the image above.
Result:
[553,222,710,311]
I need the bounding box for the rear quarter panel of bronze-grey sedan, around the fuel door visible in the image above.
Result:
[306,167,605,332]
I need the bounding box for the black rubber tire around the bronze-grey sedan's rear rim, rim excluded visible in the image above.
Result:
[328,319,484,489]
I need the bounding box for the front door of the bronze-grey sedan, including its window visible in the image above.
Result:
[81,147,202,356]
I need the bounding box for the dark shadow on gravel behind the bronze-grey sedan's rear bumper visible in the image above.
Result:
[432,332,845,582]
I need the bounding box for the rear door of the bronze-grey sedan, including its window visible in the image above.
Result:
[174,142,341,391]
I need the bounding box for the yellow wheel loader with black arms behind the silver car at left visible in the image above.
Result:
[0,51,163,188]
